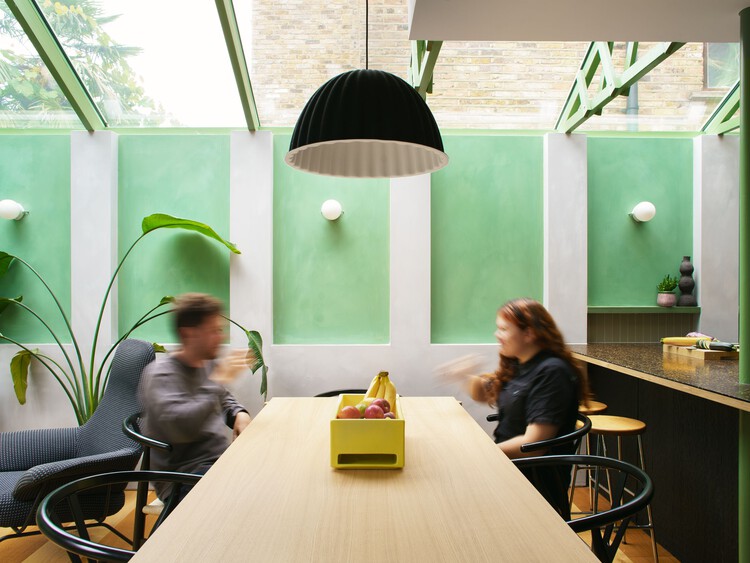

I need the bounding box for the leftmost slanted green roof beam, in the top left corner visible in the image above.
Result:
[6,0,107,131]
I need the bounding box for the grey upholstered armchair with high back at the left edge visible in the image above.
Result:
[0,340,154,541]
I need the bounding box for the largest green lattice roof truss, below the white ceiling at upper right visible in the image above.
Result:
[555,41,684,133]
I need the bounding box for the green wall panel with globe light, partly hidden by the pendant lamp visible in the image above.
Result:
[273,134,390,344]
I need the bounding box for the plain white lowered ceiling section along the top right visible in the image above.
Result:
[408,0,750,42]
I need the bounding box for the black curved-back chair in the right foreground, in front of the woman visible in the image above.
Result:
[513,455,654,562]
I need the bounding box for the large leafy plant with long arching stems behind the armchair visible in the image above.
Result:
[0,213,268,424]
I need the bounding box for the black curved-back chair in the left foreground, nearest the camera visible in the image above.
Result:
[36,471,200,562]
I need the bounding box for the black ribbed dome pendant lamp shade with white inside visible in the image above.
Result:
[285,70,448,178]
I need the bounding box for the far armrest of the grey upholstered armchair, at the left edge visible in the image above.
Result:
[0,427,79,471]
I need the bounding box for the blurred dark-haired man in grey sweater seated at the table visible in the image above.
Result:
[140,293,250,498]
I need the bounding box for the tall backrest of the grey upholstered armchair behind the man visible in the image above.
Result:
[78,339,155,456]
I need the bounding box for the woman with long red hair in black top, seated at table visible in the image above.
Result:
[470,298,588,511]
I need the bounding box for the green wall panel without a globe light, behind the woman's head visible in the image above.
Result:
[431,136,544,343]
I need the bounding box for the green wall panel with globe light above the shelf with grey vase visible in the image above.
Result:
[588,137,700,306]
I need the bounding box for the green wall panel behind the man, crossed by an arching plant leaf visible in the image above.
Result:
[118,135,232,342]
